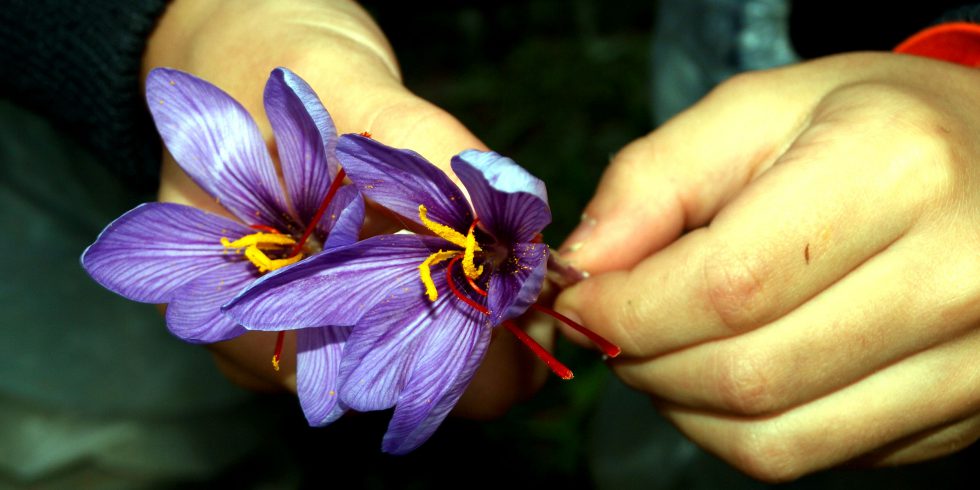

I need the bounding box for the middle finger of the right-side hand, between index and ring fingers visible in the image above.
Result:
[614,226,980,415]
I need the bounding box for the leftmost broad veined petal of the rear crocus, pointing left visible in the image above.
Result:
[82,203,253,303]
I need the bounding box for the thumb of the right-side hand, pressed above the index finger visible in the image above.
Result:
[561,64,822,274]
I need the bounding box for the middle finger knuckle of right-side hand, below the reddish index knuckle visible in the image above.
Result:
[714,345,778,415]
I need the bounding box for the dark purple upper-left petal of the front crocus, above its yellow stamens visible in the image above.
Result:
[337,134,473,232]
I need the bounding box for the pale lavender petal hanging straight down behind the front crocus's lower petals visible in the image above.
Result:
[296,327,350,427]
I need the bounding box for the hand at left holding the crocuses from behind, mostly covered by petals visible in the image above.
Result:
[143,0,552,418]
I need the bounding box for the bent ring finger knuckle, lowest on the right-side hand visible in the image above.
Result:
[730,423,806,483]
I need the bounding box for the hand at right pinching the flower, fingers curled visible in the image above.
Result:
[558,53,980,481]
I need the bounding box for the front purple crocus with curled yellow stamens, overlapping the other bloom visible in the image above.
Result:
[226,135,616,453]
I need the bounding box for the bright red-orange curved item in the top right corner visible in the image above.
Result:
[894,22,980,67]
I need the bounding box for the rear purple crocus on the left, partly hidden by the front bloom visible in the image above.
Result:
[82,68,364,424]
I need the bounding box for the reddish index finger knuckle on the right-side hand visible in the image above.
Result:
[704,242,771,334]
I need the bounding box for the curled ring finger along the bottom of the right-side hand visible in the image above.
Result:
[663,322,980,481]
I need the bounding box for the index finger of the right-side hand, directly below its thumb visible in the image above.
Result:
[559,80,948,356]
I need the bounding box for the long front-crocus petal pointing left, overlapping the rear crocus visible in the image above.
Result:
[223,235,445,330]
